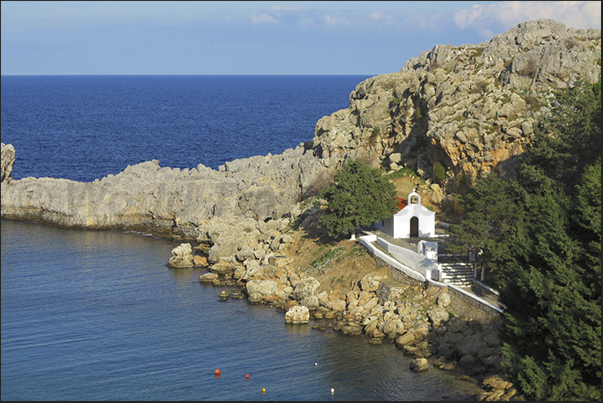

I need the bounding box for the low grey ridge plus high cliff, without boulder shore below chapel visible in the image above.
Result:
[2,20,601,246]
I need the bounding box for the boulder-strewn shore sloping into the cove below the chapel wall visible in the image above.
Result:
[168,234,523,401]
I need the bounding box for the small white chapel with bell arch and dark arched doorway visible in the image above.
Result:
[375,189,435,238]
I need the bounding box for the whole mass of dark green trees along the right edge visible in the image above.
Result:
[450,82,601,400]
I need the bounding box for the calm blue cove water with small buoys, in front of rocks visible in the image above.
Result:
[1,220,482,401]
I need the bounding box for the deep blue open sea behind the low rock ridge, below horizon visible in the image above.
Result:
[1,76,368,181]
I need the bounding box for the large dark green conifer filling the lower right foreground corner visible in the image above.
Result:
[499,164,601,400]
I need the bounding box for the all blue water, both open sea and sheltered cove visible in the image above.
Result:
[1,76,472,401]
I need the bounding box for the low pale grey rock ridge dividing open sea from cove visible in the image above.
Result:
[2,144,325,240]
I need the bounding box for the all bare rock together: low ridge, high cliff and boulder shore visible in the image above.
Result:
[1,19,601,400]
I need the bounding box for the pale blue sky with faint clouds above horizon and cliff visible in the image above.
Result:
[0,1,601,76]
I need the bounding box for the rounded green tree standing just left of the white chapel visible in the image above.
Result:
[320,160,397,237]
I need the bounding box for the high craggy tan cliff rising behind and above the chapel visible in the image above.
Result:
[313,20,601,192]
